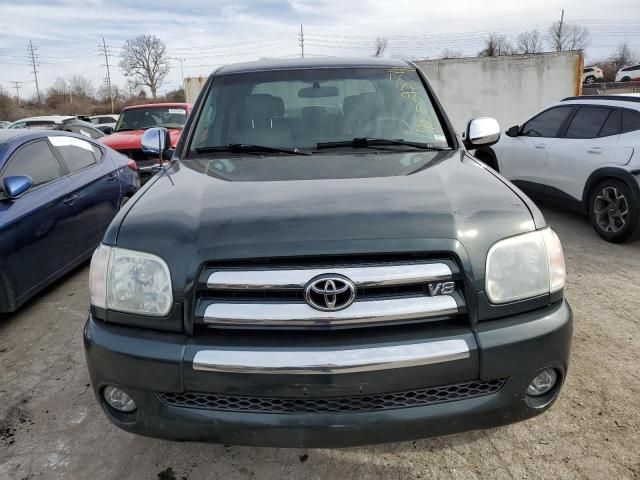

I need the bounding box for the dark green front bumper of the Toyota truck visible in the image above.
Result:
[84,301,572,447]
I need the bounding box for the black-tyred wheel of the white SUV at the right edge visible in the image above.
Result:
[589,178,640,243]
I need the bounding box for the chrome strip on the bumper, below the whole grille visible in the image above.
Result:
[193,339,470,375]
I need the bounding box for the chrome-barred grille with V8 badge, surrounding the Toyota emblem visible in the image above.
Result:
[196,259,466,328]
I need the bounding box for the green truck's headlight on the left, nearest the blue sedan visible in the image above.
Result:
[89,245,173,317]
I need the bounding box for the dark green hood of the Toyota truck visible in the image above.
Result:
[111,151,544,289]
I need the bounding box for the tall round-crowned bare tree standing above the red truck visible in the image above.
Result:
[120,35,169,98]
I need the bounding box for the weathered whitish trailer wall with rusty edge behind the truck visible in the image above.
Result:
[415,51,583,133]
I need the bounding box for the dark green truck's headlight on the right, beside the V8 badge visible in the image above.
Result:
[485,228,565,303]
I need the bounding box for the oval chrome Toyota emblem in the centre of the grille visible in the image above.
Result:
[304,275,356,312]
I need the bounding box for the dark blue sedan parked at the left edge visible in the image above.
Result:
[0,130,140,312]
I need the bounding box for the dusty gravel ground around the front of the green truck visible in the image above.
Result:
[0,209,640,480]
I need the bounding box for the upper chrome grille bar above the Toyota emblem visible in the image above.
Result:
[207,263,453,290]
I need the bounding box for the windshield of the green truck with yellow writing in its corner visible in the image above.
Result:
[190,67,450,155]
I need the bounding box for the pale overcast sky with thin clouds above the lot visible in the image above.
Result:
[0,0,640,96]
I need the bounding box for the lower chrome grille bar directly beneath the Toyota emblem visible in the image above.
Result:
[202,295,459,327]
